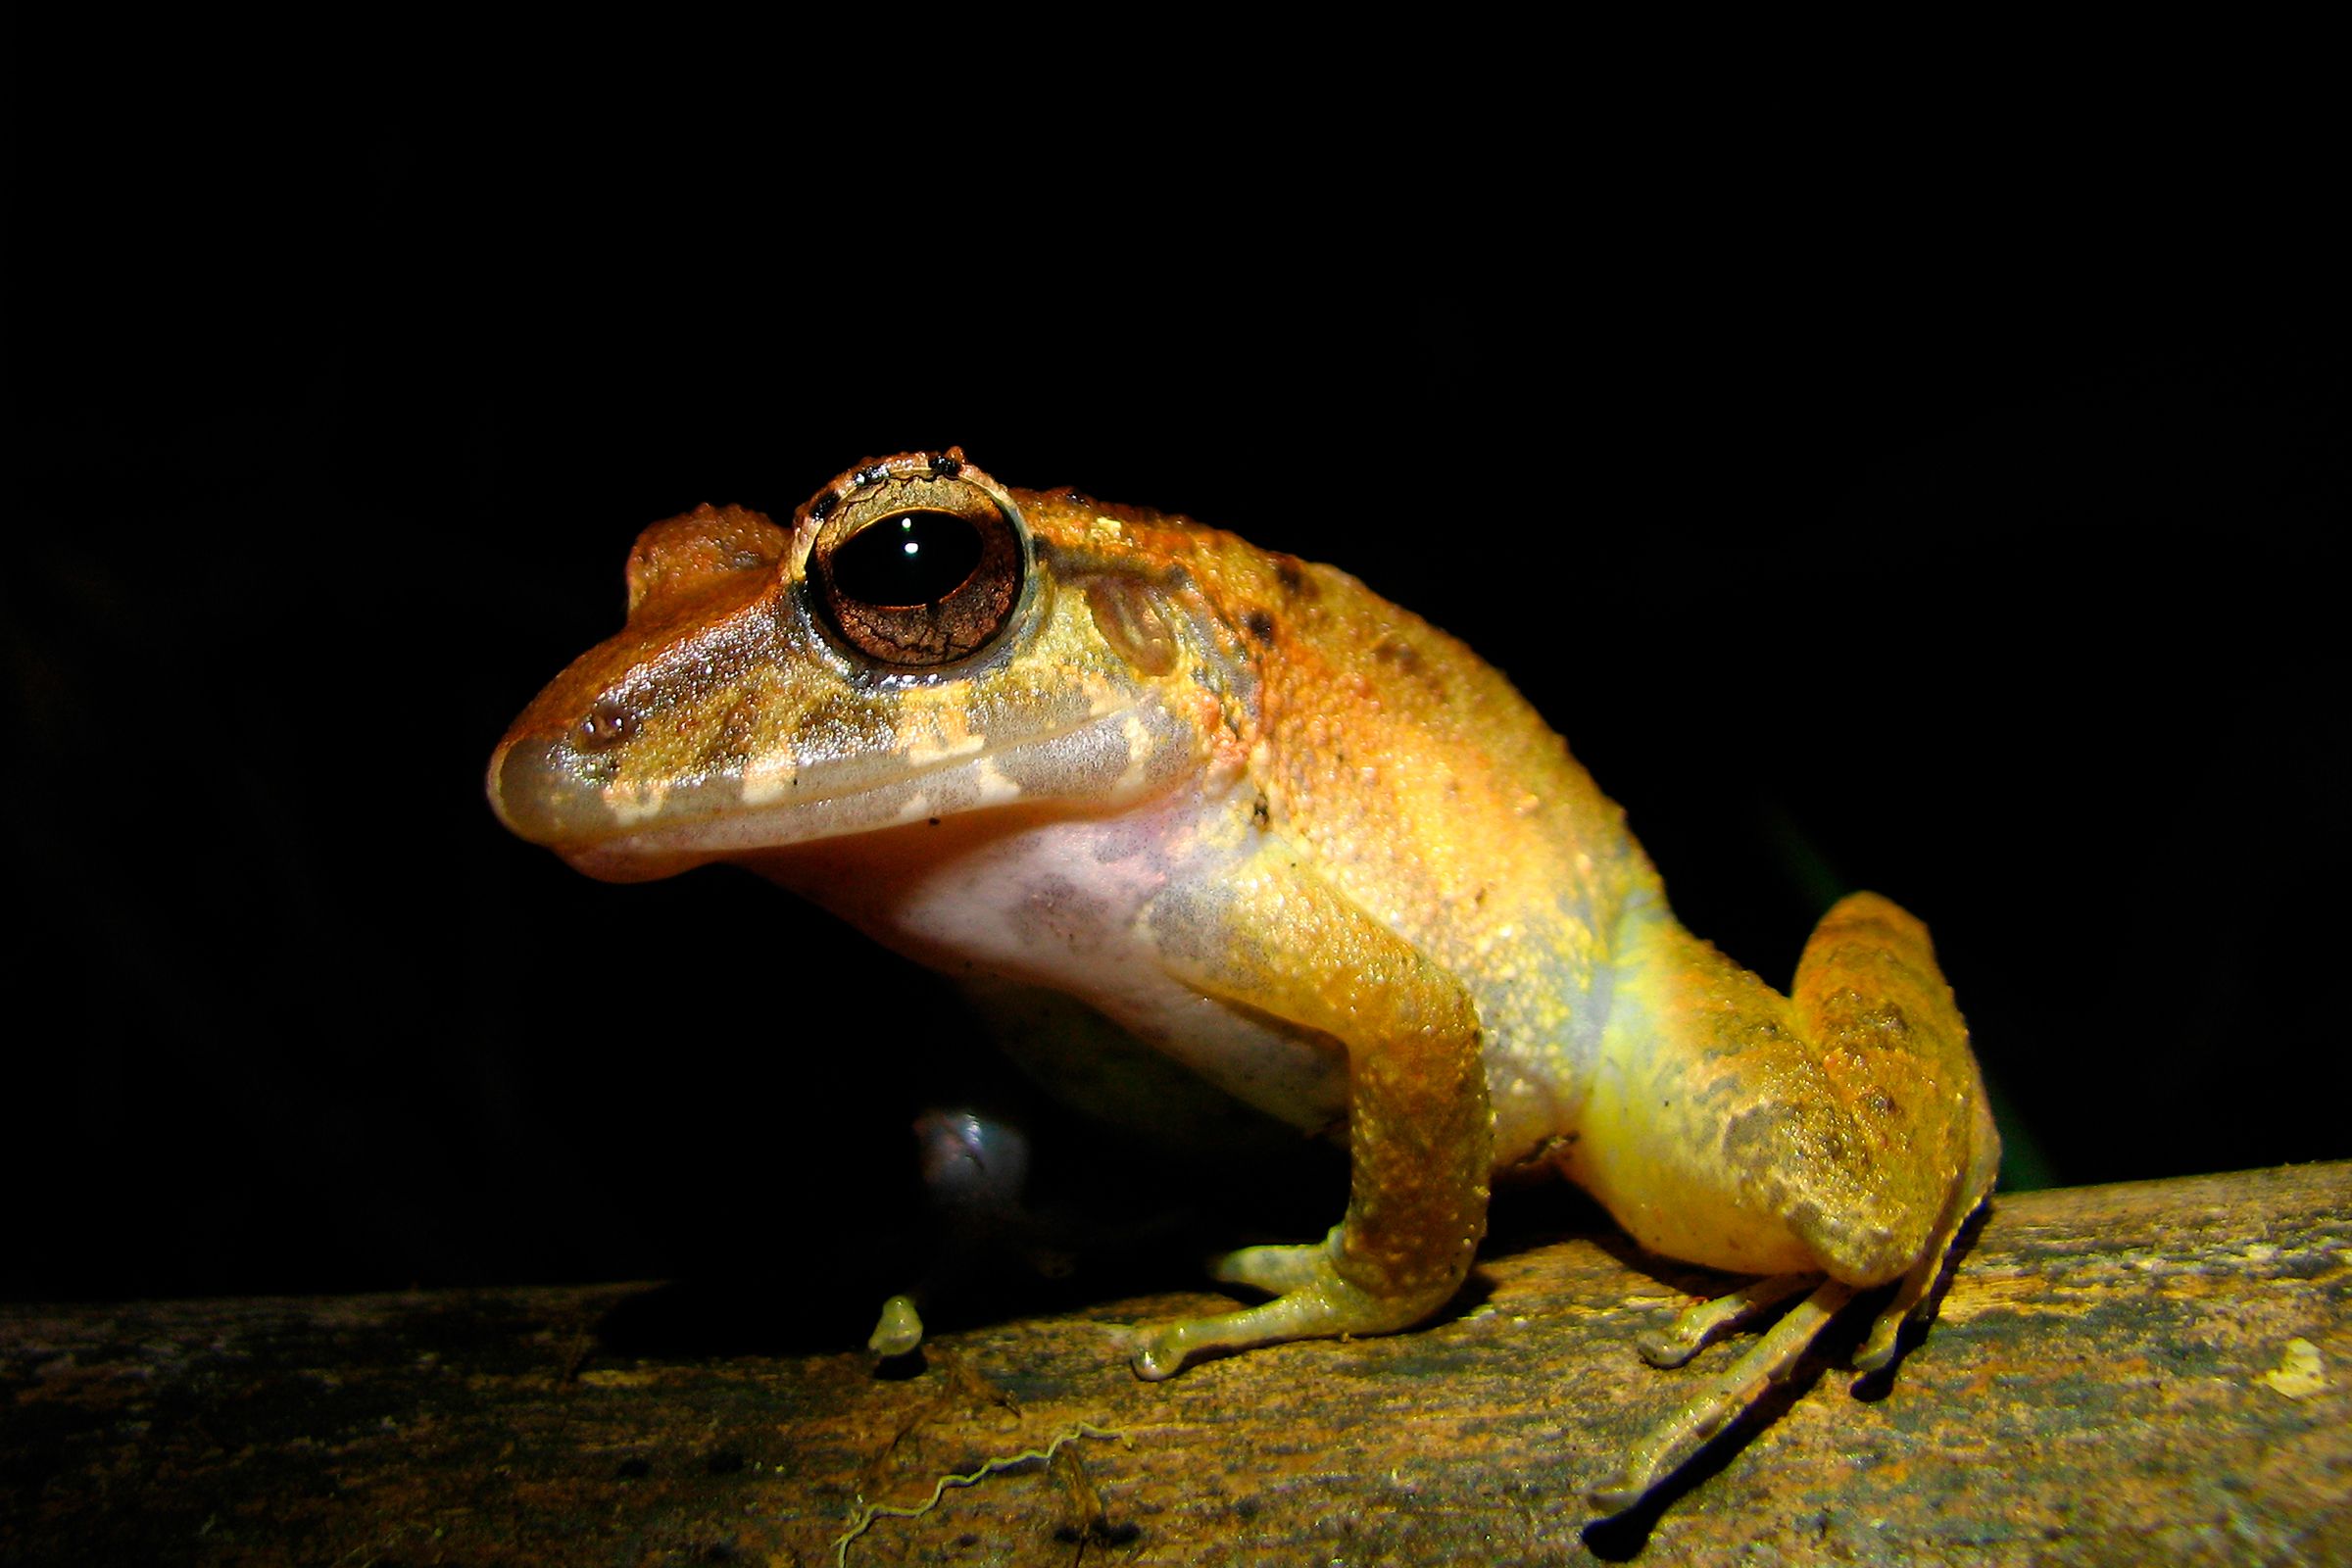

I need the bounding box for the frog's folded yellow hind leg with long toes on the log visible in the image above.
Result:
[1562,894,1999,1507]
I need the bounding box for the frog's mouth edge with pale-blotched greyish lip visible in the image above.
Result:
[489,703,1193,882]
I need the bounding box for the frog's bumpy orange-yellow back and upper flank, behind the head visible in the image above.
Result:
[1023,491,1665,1163]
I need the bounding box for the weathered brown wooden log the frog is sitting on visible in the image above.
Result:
[0,1163,2352,1568]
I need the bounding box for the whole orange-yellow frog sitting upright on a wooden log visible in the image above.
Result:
[489,447,1999,1511]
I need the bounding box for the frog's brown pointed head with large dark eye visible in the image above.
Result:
[489,449,1247,882]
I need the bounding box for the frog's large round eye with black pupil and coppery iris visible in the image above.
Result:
[809,465,1025,670]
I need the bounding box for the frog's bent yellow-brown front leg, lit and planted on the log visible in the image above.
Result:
[1131,844,1494,1378]
